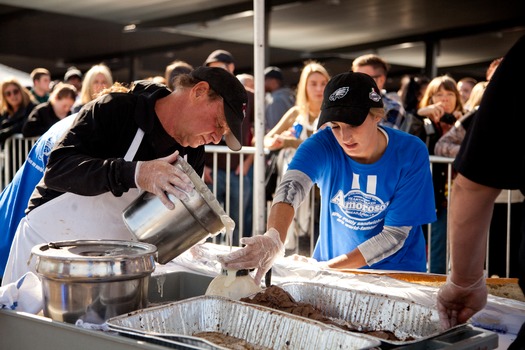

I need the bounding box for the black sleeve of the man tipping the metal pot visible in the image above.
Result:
[44,95,137,196]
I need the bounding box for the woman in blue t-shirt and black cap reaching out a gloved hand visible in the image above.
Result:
[220,72,436,282]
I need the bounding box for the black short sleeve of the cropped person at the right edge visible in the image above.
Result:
[454,36,525,189]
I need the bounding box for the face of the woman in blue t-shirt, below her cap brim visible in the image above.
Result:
[332,114,380,163]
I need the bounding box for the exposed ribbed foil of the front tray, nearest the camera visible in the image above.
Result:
[107,296,381,350]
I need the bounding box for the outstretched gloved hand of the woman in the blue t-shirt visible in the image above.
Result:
[218,228,284,285]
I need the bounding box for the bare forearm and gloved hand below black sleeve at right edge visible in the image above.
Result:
[437,173,501,329]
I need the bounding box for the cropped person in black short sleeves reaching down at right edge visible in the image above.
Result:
[437,36,525,349]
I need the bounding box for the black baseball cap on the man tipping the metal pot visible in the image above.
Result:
[190,67,248,151]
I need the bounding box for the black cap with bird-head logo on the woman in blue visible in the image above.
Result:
[318,72,383,127]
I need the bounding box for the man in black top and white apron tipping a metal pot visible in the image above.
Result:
[2,67,246,285]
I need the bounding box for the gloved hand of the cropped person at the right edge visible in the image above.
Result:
[437,275,487,330]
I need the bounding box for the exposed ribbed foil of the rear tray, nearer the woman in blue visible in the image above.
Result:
[278,282,443,345]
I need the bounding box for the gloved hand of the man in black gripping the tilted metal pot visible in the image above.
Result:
[135,151,195,210]
